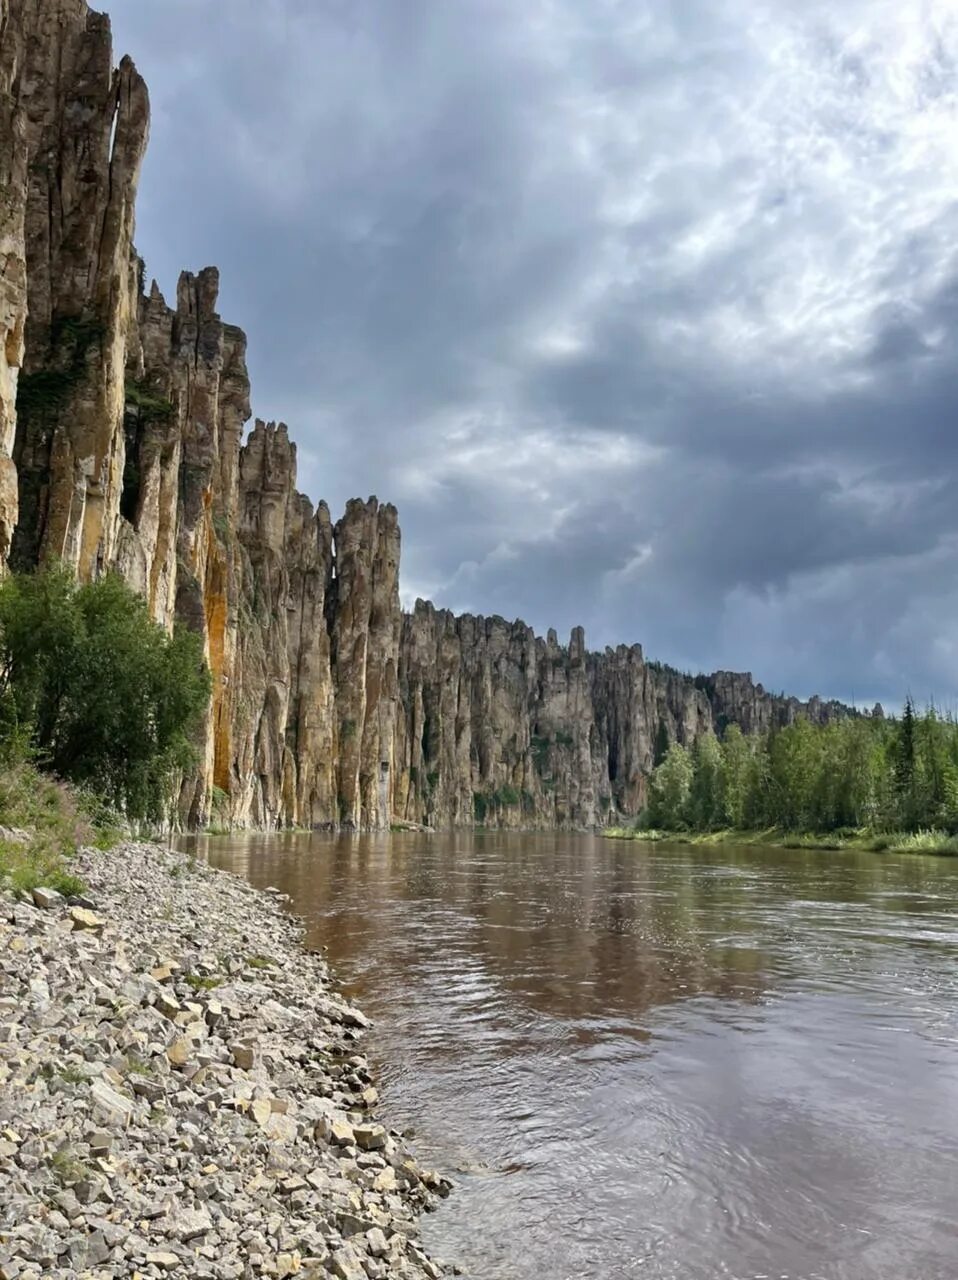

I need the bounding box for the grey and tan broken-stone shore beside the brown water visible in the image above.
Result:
[0,844,452,1280]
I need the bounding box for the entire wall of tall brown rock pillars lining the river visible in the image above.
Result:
[0,0,847,829]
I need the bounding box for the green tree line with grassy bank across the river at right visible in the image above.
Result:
[607,699,958,854]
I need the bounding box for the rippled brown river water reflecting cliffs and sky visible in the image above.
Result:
[181,833,958,1280]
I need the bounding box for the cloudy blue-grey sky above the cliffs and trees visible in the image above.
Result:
[108,0,958,705]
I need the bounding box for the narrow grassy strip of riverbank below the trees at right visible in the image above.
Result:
[602,827,958,858]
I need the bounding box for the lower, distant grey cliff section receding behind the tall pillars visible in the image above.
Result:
[394,600,845,827]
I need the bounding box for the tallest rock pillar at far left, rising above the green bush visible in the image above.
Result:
[10,0,149,579]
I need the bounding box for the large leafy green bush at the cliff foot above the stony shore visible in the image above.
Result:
[0,567,210,819]
